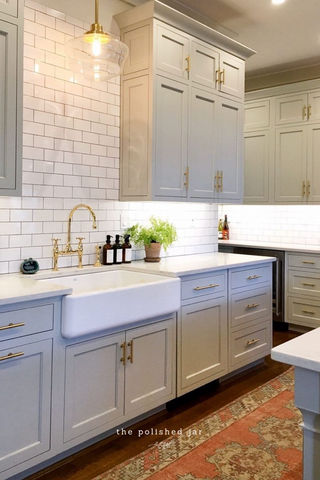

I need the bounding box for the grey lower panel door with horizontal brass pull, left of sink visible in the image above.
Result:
[0,339,52,471]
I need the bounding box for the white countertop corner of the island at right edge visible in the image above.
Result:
[271,328,320,372]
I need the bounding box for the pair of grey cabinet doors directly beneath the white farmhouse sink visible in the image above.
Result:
[63,318,176,443]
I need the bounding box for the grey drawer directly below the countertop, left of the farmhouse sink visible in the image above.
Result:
[0,305,53,341]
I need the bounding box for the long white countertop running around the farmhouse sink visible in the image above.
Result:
[0,252,274,305]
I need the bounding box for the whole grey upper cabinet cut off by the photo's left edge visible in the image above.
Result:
[0,0,23,196]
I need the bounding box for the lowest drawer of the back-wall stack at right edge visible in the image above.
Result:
[287,297,320,328]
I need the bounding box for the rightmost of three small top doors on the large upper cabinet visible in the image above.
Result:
[220,50,244,98]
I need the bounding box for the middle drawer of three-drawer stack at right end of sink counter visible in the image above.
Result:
[231,287,271,327]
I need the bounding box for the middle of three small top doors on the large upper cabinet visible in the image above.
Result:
[190,41,219,90]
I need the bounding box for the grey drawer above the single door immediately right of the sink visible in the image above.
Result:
[181,273,226,300]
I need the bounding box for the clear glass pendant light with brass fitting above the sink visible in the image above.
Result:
[65,0,129,82]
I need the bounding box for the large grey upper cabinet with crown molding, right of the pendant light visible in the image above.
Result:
[115,1,253,202]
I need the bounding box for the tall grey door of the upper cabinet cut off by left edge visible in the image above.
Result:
[0,20,17,195]
